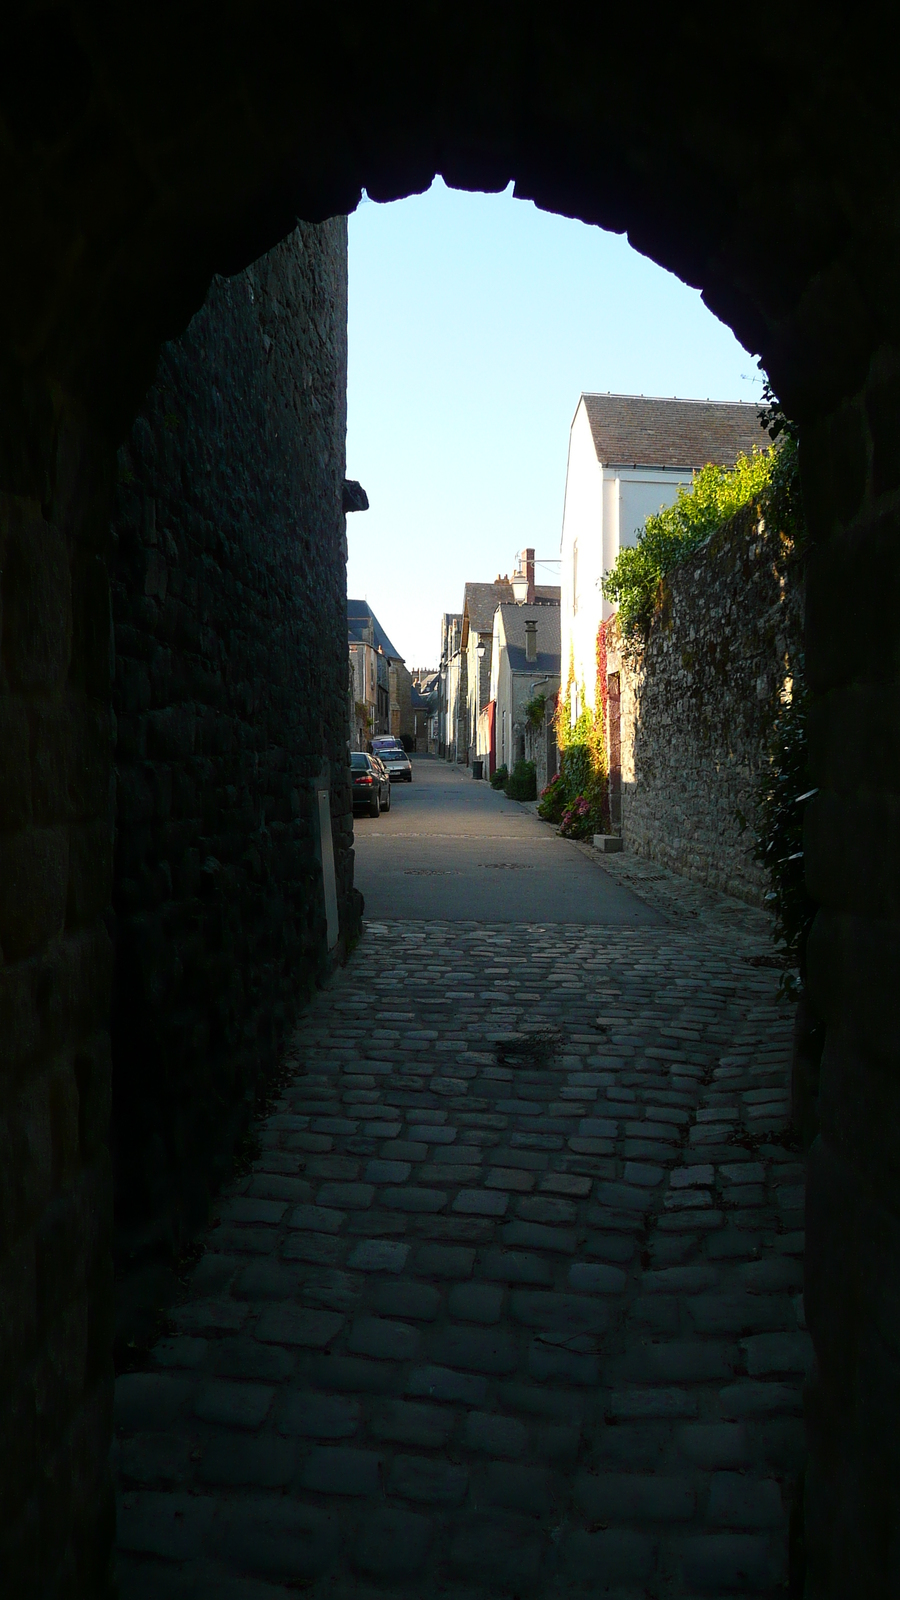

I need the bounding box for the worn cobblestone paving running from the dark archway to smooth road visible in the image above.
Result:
[115,768,810,1600]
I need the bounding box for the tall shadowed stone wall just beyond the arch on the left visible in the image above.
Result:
[112,219,359,1342]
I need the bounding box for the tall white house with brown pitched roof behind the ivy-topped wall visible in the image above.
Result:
[560,394,770,718]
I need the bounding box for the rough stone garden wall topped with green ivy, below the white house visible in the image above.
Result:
[607,506,804,906]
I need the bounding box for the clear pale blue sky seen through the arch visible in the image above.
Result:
[348,181,762,667]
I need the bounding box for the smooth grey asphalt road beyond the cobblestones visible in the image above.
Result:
[356,757,661,926]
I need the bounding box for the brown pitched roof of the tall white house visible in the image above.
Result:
[581,394,772,469]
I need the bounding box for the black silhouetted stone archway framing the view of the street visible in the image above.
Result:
[0,3,900,1595]
